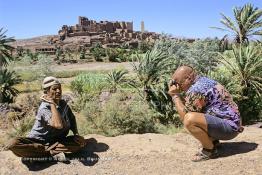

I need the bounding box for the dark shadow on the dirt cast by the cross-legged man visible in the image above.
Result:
[22,138,109,171]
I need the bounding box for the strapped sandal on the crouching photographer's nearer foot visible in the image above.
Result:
[192,147,219,162]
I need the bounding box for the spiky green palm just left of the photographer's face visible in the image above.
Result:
[133,48,178,124]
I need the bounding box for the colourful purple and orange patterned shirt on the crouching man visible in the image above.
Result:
[185,77,240,131]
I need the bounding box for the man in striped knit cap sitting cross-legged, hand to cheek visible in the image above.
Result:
[7,77,85,161]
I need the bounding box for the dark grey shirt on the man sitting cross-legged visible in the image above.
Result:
[28,100,77,143]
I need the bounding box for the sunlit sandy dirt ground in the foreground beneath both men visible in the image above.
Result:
[0,127,262,175]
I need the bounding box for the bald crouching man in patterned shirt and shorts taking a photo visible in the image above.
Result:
[168,66,243,161]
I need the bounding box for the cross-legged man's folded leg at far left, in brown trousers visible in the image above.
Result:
[6,137,50,158]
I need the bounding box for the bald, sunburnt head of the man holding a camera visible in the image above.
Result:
[172,66,196,91]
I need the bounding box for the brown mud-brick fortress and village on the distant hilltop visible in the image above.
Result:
[13,16,160,55]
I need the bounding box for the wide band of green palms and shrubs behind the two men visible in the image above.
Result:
[0,4,262,142]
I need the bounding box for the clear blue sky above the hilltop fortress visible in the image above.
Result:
[0,0,262,39]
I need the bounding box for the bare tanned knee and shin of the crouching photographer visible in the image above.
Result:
[184,112,214,149]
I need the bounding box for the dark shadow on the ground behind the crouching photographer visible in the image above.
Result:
[219,142,258,157]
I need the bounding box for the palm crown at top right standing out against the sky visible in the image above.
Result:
[212,4,262,43]
